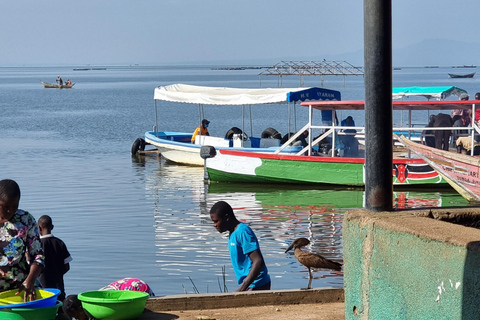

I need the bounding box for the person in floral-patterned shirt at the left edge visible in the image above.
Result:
[0,179,45,301]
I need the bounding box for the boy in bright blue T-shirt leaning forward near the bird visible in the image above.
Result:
[210,201,271,291]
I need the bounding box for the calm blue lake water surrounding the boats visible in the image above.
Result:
[0,67,472,295]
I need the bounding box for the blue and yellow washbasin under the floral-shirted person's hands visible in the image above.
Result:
[0,288,60,309]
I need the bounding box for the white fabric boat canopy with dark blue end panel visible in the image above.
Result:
[154,84,341,105]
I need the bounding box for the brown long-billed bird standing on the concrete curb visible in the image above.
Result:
[285,238,342,289]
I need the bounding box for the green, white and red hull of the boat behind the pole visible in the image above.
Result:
[206,150,447,187]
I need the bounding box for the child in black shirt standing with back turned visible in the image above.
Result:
[38,215,72,301]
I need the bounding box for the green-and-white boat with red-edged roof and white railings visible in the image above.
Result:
[206,100,480,187]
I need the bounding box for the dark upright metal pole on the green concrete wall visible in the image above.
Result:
[364,0,393,211]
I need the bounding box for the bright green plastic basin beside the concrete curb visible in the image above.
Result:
[78,290,149,320]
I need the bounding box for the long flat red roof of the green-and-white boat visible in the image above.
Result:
[301,100,480,110]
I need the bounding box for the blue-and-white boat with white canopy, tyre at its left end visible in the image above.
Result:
[144,84,341,166]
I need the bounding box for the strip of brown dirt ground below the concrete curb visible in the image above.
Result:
[139,302,345,320]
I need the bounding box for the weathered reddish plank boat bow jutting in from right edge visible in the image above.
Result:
[400,136,480,202]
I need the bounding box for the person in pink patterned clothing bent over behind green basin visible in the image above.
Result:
[62,278,155,320]
